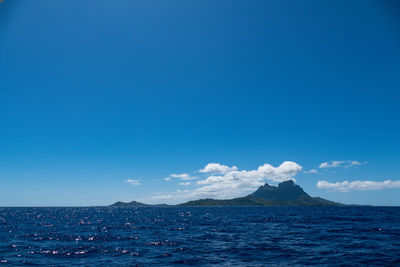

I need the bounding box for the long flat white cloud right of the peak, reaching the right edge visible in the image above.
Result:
[317,180,400,192]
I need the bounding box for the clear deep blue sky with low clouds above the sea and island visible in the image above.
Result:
[0,0,400,206]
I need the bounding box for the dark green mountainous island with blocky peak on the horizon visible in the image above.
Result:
[111,180,345,207]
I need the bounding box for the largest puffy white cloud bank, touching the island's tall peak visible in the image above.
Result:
[153,161,302,202]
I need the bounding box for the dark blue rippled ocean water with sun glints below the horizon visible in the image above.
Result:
[0,207,400,266]
